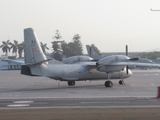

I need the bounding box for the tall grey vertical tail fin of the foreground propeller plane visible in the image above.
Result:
[24,28,47,63]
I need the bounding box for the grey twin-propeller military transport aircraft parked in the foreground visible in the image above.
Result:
[21,28,160,87]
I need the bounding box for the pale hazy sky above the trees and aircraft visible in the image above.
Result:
[0,0,160,54]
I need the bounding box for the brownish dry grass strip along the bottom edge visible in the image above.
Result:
[0,108,160,120]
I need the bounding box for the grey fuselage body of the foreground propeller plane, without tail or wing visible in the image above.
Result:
[28,64,132,81]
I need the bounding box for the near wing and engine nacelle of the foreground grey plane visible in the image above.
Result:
[96,55,160,72]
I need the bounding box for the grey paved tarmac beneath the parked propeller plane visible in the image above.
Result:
[0,69,160,108]
